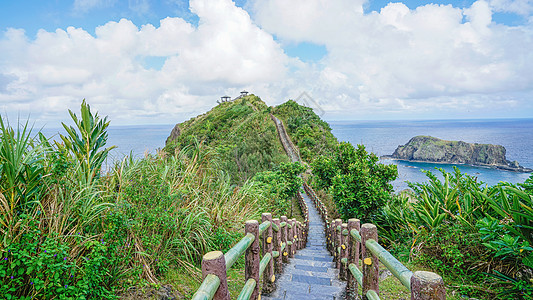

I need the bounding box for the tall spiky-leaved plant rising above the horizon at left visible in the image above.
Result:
[61,99,115,183]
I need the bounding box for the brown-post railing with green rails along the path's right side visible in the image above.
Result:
[304,183,446,300]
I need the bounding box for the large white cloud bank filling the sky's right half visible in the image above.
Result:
[252,0,533,118]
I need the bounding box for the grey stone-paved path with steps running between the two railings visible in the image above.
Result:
[261,193,346,300]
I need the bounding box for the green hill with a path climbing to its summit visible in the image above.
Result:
[166,95,337,184]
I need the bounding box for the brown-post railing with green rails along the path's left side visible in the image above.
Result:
[192,193,309,300]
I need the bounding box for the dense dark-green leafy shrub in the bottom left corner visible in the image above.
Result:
[0,215,123,299]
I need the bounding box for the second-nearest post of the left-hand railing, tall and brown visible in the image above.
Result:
[244,220,260,299]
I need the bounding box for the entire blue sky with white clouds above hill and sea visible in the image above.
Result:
[0,0,533,124]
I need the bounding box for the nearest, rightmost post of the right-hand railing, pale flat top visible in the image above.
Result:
[411,271,446,300]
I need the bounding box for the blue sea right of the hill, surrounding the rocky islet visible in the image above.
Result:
[329,119,533,191]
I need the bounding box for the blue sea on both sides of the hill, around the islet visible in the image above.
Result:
[43,119,533,191]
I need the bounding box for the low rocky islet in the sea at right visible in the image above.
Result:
[391,136,533,172]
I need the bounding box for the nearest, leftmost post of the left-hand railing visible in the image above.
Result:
[202,251,230,300]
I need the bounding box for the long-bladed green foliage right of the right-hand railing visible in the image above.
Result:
[376,168,533,299]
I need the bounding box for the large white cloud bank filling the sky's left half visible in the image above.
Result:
[0,0,287,123]
